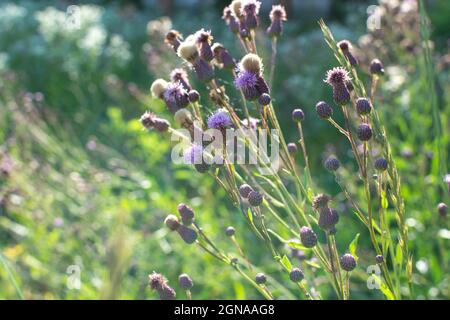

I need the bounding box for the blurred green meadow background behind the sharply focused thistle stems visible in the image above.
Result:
[0,0,450,299]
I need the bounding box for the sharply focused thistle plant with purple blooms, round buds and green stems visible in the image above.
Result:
[141,0,414,300]
